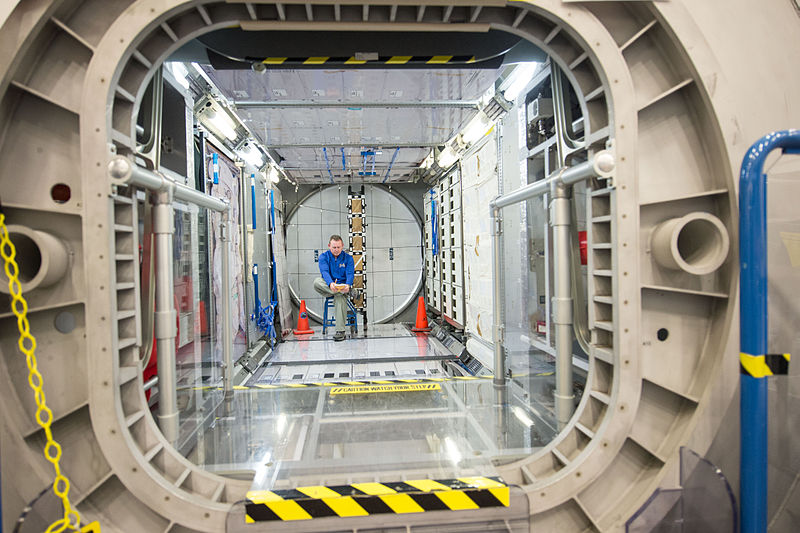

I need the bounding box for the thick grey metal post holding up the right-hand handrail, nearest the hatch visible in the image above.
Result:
[550,185,575,429]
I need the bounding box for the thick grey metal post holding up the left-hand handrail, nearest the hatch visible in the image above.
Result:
[152,187,179,444]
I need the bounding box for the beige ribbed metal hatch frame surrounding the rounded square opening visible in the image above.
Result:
[0,0,736,531]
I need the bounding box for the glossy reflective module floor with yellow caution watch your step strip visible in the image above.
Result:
[184,327,554,488]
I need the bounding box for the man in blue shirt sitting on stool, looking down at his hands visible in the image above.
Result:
[314,235,355,341]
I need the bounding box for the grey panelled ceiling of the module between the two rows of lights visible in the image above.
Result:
[204,66,499,183]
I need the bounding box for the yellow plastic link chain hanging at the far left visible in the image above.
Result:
[0,213,81,533]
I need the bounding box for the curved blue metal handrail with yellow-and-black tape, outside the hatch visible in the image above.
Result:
[739,130,800,533]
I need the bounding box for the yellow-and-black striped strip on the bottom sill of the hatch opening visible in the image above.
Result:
[245,477,510,524]
